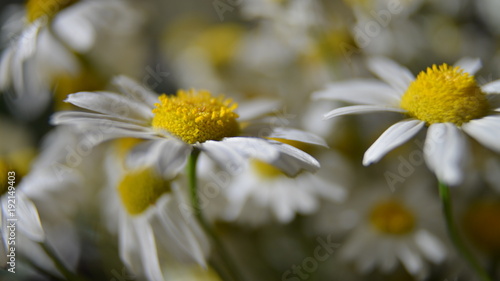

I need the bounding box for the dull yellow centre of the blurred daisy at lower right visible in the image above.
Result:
[370,200,415,235]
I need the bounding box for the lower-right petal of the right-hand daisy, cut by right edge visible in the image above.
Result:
[462,115,500,152]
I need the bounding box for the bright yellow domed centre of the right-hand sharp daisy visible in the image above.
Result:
[401,64,490,126]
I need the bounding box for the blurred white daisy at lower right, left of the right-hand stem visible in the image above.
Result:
[323,182,447,278]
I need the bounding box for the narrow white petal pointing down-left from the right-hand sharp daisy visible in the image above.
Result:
[363,119,425,166]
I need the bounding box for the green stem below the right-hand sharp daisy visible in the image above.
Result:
[439,182,492,281]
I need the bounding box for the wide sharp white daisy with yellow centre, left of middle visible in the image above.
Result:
[52,77,325,178]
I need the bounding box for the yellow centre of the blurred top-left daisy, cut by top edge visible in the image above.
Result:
[26,0,78,23]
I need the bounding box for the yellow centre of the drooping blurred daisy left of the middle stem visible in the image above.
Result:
[118,168,170,215]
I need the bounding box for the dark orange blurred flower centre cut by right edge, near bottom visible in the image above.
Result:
[464,200,500,255]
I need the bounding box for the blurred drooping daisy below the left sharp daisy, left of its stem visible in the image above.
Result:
[102,138,209,281]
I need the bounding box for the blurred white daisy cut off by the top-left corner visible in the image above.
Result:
[0,0,146,118]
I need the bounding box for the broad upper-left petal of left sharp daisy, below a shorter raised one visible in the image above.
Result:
[65,92,153,120]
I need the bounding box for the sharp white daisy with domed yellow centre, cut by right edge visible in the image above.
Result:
[313,57,500,185]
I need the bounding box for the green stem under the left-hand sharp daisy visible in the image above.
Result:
[186,149,243,281]
